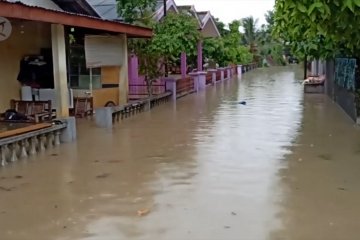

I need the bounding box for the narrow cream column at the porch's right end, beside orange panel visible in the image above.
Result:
[119,34,129,105]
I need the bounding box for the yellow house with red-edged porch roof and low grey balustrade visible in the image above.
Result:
[0,0,152,148]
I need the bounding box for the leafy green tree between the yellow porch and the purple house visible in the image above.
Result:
[117,0,200,96]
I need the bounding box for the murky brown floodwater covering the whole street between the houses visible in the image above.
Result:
[0,67,360,240]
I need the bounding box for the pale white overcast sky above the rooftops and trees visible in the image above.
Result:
[175,0,275,25]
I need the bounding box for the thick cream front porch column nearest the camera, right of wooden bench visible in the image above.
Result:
[51,24,69,117]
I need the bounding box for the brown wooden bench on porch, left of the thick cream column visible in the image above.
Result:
[5,99,53,123]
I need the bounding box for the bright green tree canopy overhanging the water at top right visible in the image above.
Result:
[273,0,360,58]
